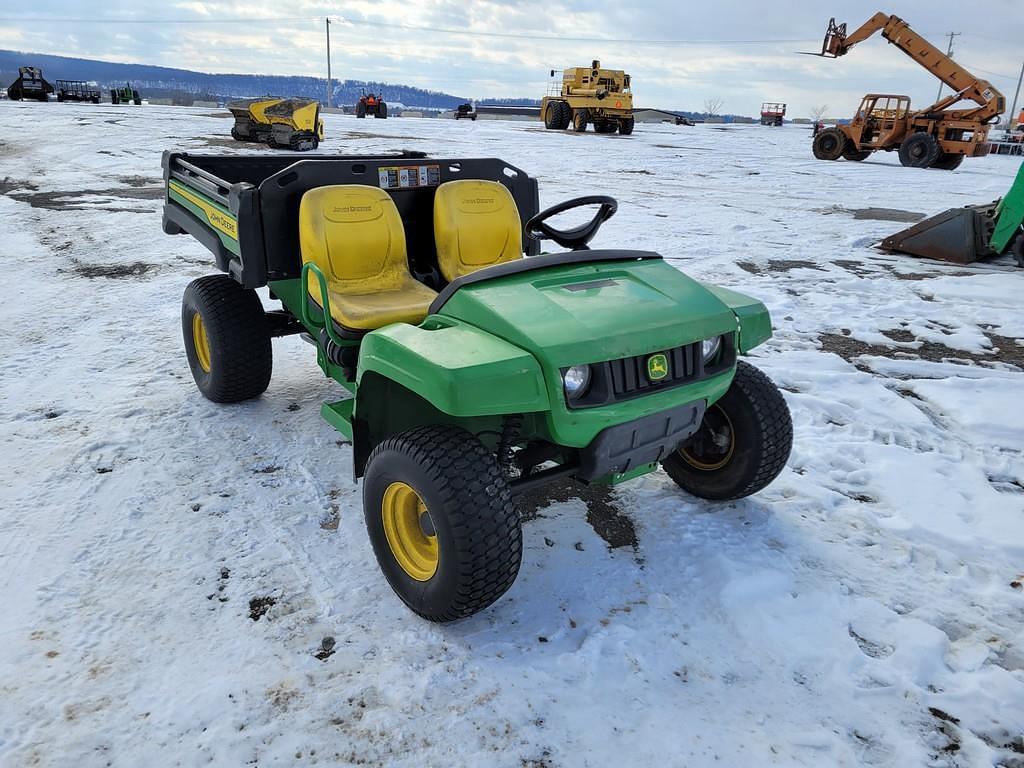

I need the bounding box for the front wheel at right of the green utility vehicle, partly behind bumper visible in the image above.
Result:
[662,360,793,501]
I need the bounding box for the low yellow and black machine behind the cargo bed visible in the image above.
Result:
[227,96,324,152]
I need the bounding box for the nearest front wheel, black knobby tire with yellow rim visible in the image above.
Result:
[362,426,522,622]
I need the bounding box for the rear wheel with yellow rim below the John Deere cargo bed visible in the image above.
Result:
[181,274,273,402]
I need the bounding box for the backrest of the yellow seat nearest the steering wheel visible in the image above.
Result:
[434,179,522,283]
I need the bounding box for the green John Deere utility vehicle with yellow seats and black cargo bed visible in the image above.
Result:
[163,153,792,622]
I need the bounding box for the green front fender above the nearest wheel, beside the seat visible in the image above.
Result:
[356,316,549,417]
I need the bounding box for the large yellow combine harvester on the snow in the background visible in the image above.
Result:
[541,58,633,136]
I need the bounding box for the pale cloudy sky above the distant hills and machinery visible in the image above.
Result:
[0,0,1024,117]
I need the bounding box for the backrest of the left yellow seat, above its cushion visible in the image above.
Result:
[299,184,409,298]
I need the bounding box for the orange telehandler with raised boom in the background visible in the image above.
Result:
[812,11,1007,170]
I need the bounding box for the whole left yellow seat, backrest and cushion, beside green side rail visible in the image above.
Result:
[299,184,437,332]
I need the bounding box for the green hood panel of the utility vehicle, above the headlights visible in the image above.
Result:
[439,259,737,370]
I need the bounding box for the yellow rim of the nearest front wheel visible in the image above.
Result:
[381,482,440,582]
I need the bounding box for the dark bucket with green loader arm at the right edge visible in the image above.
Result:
[881,166,1024,266]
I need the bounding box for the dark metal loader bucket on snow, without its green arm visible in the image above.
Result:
[881,203,996,264]
